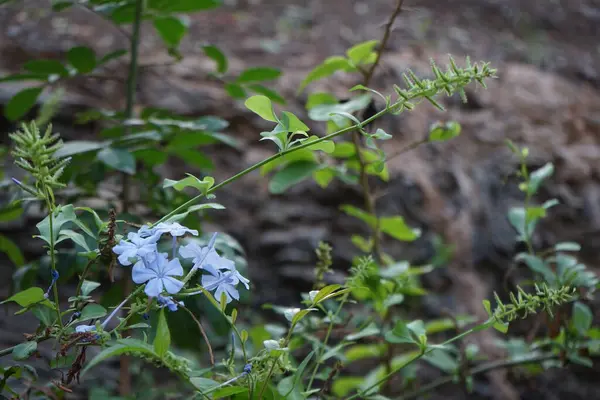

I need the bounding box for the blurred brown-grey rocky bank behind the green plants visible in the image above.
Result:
[0,0,600,399]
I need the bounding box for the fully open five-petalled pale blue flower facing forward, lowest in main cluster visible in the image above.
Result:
[131,253,183,297]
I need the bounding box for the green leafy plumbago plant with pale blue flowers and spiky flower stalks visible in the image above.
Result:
[0,0,600,400]
